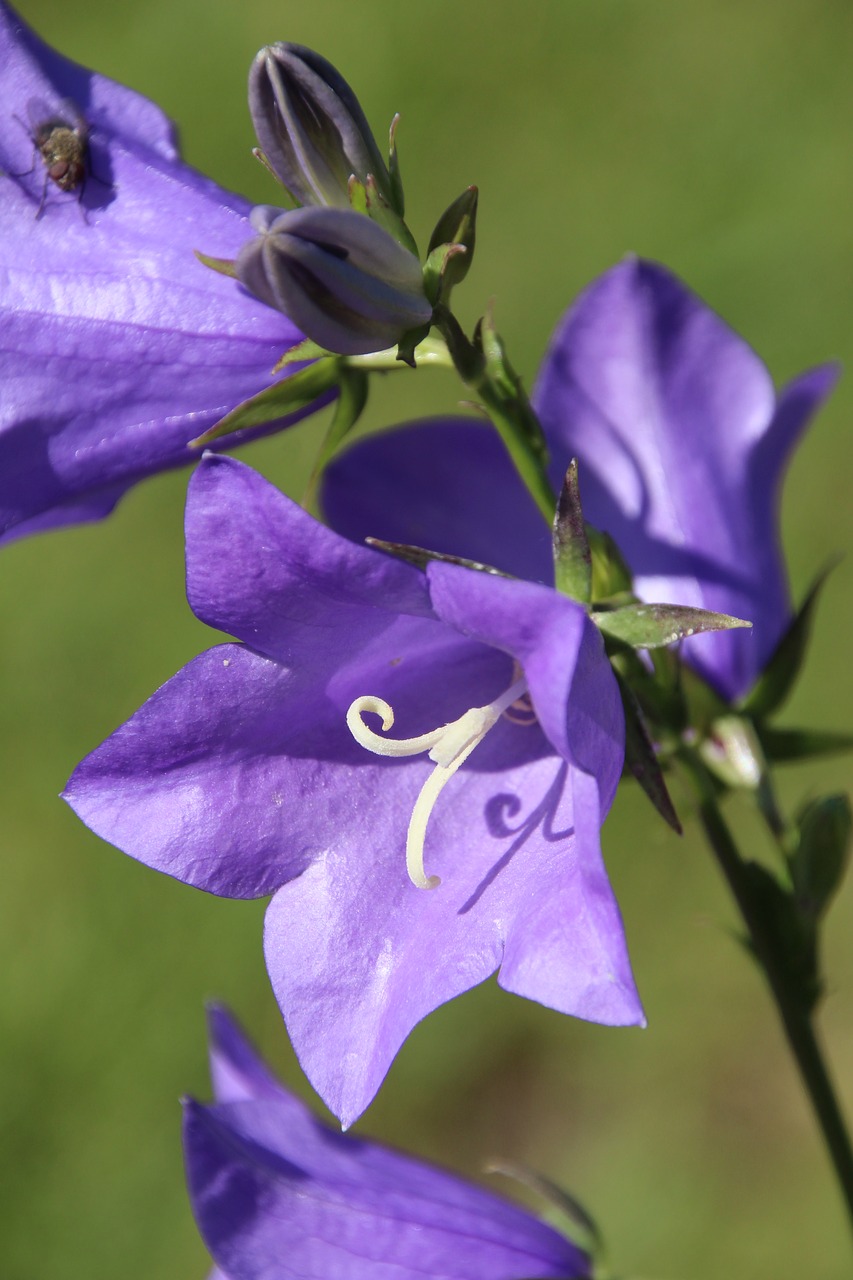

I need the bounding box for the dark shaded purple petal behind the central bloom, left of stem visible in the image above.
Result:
[321,417,553,582]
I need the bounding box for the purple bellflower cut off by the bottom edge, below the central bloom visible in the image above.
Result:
[183,1009,590,1280]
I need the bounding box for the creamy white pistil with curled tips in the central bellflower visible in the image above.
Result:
[347,677,528,888]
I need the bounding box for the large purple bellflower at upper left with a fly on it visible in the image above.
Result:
[0,3,318,536]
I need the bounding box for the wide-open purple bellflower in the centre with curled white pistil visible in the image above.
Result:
[65,454,643,1125]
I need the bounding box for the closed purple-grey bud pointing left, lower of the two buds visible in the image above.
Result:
[236,206,432,356]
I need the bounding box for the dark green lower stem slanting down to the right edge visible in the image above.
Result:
[679,749,853,1230]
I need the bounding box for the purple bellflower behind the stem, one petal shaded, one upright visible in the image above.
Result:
[323,259,836,699]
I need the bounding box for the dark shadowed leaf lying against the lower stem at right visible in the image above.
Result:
[743,861,824,1014]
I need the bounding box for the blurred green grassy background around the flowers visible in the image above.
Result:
[0,0,853,1280]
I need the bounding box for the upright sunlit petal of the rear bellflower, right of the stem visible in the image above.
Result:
[535,260,829,696]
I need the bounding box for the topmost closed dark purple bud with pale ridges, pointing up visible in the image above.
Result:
[248,44,403,216]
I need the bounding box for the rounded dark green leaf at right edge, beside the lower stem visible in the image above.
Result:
[789,795,853,922]
